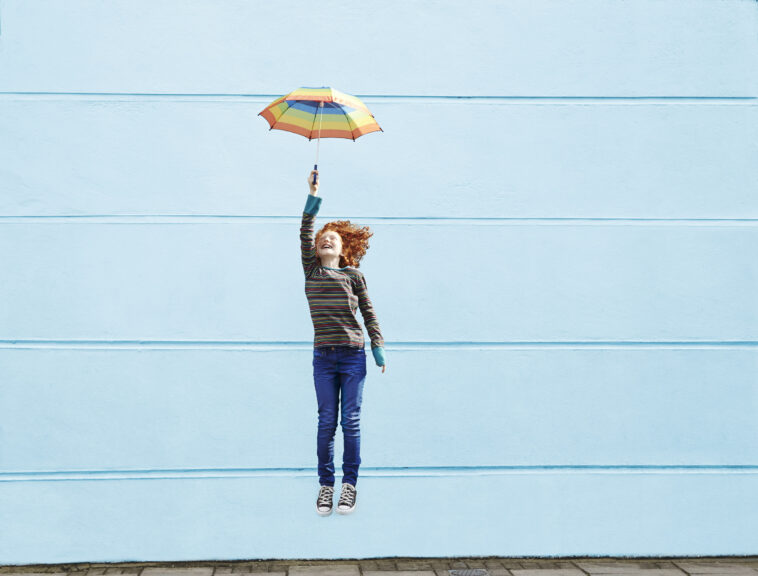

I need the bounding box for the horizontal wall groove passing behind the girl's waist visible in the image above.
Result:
[0,339,758,351]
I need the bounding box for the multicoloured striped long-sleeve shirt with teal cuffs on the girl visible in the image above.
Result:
[300,194,384,366]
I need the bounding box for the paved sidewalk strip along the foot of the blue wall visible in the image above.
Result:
[0,556,758,576]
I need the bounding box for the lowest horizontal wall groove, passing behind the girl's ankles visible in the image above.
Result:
[0,465,758,482]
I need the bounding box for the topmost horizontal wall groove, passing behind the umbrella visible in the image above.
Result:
[0,91,758,105]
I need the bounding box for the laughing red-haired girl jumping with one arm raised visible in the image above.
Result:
[300,170,386,516]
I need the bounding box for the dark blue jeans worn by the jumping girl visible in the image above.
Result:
[313,346,366,486]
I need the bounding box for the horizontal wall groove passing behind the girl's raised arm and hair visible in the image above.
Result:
[0,214,758,226]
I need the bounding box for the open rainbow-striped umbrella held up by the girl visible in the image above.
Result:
[258,86,384,184]
